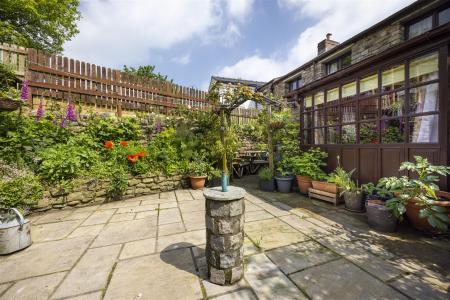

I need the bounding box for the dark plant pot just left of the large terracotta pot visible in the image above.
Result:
[366,199,397,232]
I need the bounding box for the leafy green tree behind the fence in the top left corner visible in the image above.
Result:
[0,0,81,53]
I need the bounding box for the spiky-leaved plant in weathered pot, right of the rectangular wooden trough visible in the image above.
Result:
[328,161,364,212]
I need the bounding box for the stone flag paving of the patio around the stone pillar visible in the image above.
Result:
[0,189,450,300]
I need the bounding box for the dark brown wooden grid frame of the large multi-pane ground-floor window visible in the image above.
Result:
[300,48,442,146]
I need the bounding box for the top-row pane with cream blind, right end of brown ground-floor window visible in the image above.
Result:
[409,53,438,83]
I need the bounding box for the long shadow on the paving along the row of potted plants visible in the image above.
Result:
[232,176,450,286]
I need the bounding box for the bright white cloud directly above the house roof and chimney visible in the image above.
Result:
[218,0,414,81]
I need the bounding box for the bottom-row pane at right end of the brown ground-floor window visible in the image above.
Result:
[409,115,439,143]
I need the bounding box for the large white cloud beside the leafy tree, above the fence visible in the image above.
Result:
[64,0,253,67]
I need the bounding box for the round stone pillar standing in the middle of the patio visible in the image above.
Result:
[203,186,245,285]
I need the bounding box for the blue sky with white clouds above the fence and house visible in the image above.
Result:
[64,0,414,90]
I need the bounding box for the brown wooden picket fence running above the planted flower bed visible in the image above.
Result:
[0,44,257,124]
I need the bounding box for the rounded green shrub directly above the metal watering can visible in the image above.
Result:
[0,162,43,210]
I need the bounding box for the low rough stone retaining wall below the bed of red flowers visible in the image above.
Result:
[35,174,189,211]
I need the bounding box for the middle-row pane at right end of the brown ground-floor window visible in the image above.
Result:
[409,83,439,114]
